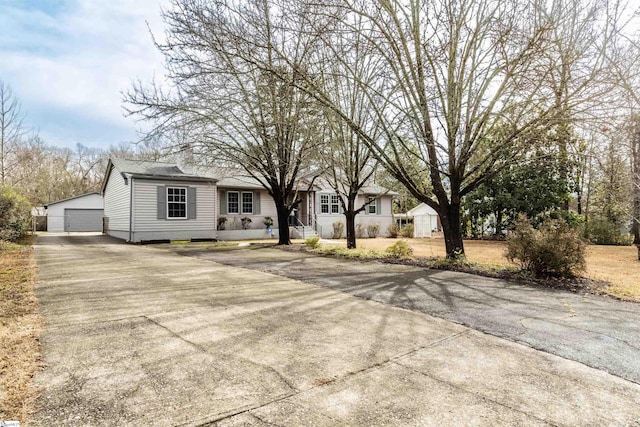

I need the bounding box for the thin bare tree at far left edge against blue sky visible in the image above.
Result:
[0,79,26,185]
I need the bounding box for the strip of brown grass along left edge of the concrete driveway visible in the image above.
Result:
[0,237,42,424]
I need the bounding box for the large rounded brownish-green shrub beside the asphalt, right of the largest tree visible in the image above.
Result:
[506,215,586,277]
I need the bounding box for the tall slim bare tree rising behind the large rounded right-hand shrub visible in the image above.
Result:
[540,0,617,210]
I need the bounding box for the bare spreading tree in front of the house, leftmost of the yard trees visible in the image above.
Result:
[127,0,321,244]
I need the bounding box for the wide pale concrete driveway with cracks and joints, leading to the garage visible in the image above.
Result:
[33,236,640,426]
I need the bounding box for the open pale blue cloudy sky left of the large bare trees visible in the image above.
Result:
[0,0,166,148]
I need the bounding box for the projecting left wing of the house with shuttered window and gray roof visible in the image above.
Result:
[102,158,217,243]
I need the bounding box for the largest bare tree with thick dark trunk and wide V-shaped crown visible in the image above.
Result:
[272,0,614,258]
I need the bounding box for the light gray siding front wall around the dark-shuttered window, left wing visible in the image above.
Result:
[132,179,216,242]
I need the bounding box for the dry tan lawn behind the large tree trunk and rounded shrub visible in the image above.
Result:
[358,239,640,302]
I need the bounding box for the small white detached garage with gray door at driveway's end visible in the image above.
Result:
[44,193,104,231]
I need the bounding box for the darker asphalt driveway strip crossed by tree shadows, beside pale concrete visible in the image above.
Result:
[170,245,640,384]
